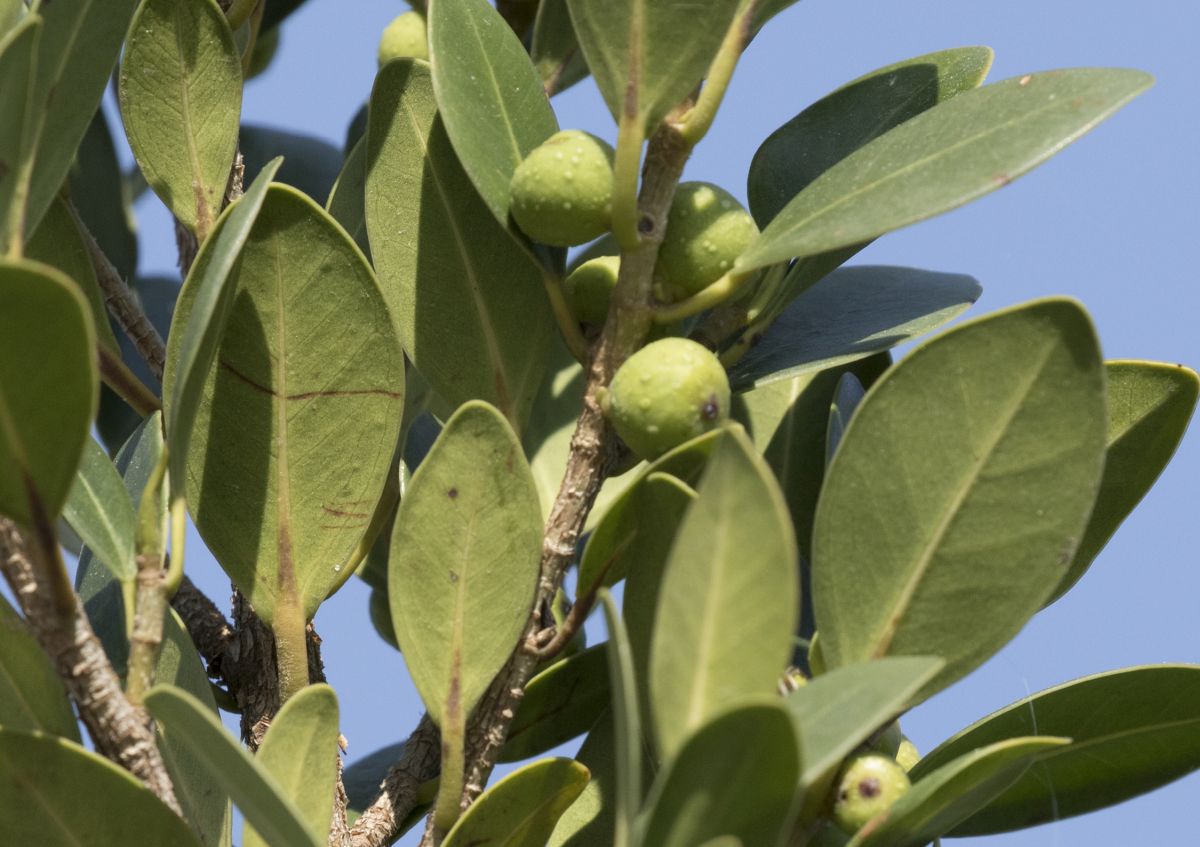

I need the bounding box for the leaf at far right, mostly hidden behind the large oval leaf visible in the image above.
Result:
[1046,361,1200,605]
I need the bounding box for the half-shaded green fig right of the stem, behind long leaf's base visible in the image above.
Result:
[654,182,758,302]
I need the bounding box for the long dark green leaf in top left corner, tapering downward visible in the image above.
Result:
[26,0,137,233]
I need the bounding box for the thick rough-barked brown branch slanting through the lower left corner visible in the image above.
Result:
[0,518,181,815]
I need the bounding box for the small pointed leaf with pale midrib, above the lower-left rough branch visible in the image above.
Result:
[62,438,138,583]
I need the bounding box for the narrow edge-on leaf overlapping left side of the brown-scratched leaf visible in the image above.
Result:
[162,154,280,518]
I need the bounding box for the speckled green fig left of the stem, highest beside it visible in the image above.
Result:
[509,130,613,247]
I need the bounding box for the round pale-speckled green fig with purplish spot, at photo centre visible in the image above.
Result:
[600,338,730,458]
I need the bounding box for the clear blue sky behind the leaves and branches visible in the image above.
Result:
[126,0,1200,847]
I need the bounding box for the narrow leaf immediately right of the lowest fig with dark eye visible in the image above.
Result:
[846,735,1069,847]
